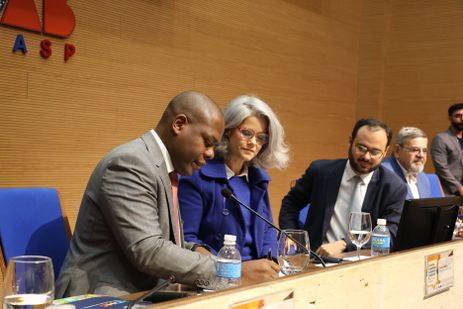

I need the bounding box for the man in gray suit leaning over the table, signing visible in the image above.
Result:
[56,91,278,298]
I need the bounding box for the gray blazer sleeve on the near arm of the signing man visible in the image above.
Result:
[98,154,215,285]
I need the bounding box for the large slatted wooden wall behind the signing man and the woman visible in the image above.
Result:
[0,0,360,226]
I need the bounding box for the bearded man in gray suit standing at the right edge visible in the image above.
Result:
[431,103,463,196]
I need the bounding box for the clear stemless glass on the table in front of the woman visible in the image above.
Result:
[278,229,310,275]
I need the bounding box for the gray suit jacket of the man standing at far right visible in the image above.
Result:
[431,129,463,195]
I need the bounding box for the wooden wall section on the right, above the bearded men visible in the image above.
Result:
[357,0,463,172]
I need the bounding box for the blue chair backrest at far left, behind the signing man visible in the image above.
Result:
[0,188,70,279]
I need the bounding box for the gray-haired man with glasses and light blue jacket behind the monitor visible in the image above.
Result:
[382,127,442,199]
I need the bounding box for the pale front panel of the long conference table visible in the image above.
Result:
[123,240,463,309]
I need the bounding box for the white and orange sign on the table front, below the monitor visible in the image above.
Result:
[424,250,453,298]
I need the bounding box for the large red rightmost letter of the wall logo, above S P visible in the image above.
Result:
[43,0,76,38]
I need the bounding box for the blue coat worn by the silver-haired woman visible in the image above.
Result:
[178,159,277,259]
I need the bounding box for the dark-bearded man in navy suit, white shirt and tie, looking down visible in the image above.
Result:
[279,118,407,256]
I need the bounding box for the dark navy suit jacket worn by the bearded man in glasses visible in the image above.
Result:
[279,159,407,250]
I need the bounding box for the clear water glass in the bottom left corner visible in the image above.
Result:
[2,255,55,309]
